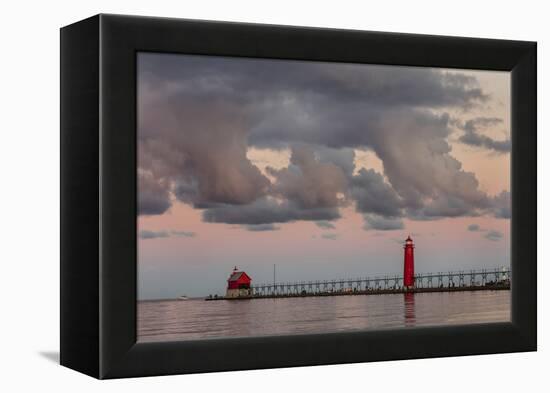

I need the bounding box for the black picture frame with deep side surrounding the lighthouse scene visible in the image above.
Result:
[61,15,537,379]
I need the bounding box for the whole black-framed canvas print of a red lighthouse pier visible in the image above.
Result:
[61,15,537,378]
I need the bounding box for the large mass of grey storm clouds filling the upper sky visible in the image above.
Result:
[138,54,509,230]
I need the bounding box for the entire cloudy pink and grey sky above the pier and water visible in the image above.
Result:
[137,53,512,299]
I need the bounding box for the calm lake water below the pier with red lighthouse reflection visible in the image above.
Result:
[137,290,510,342]
